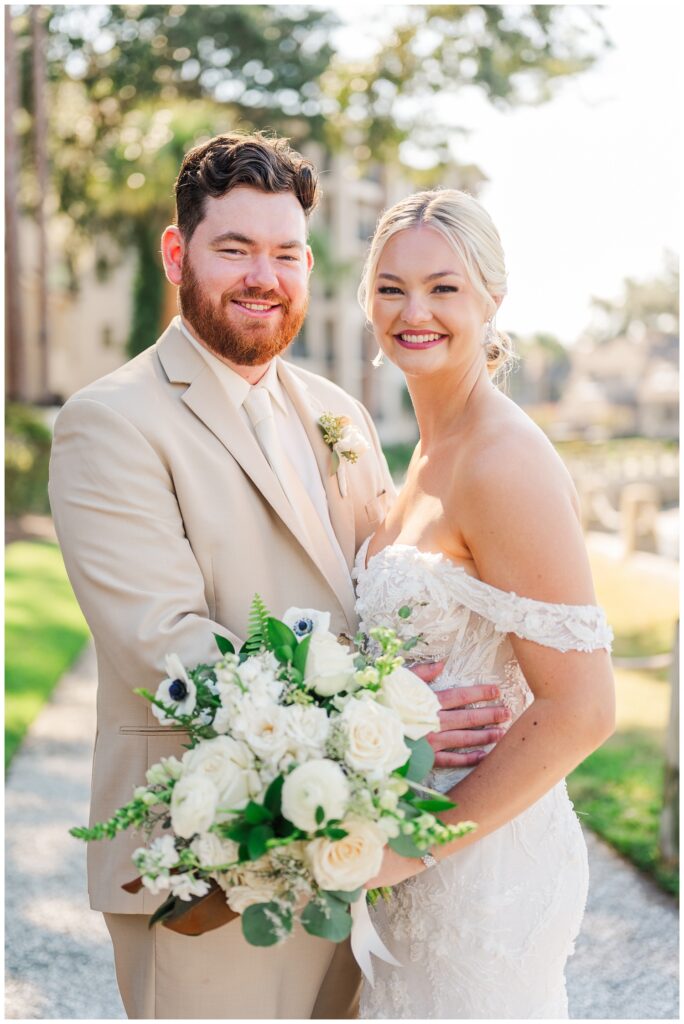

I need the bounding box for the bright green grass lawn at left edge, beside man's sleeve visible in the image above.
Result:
[5,541,88,767]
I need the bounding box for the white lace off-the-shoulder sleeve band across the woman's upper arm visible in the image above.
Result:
[448,575,612,651]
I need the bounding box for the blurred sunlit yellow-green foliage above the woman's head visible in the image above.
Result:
[323,4,609,165]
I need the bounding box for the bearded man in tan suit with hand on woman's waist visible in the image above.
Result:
[50,134,501,1019]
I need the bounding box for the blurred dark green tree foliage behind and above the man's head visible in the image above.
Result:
[11,5,336,354]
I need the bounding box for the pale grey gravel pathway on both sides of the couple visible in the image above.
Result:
[5,647,679,1020]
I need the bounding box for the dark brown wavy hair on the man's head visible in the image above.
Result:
[175,132,318,243]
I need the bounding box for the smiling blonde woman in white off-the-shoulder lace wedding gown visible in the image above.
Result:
[354,189,614,1019]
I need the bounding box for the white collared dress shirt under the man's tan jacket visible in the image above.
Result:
[174,316,348,571]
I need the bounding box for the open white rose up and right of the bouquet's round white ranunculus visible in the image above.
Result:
[340,699,411,778]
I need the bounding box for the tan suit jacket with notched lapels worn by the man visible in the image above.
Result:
[49,326,394,913]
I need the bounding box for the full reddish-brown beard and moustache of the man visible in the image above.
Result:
[178,257,308,367]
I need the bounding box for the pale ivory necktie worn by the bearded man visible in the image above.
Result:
[243,387,353,606]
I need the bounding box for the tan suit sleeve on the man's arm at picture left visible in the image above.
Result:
[49,398,240,688]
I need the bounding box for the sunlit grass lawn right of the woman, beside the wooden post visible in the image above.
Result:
[567,553,679,893]
